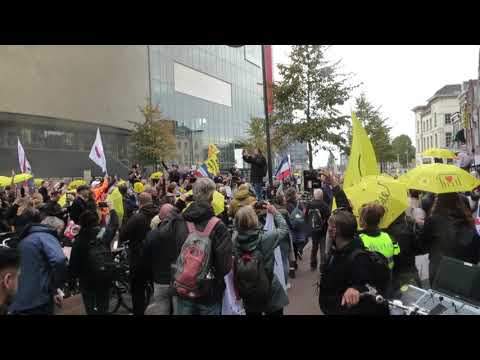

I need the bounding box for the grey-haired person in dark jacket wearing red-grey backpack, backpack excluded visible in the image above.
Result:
[173,178,232,315]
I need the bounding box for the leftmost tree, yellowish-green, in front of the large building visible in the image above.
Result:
[130,99,176,169]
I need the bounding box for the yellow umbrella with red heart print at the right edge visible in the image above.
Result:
[400,164,480,194]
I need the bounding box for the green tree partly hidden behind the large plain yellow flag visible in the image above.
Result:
[350,93,396,163]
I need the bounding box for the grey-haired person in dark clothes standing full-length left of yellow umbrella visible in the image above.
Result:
[306,189,330,271]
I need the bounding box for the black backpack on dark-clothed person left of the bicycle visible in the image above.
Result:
[87,228,115,285]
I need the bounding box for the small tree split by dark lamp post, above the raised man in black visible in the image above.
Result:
[239,115,288,154]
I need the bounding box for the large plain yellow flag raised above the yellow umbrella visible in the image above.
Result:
[343,112,380,189]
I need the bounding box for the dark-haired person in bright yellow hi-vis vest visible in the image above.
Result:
[359,203,400,270]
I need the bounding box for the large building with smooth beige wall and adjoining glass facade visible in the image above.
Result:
[0,45,264,177]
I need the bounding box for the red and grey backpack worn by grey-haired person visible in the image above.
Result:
[173,217,220,299]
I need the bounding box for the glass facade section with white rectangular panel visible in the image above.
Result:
[150,45,264,167]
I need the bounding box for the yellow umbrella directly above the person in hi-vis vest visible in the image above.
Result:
[334,175,408,229]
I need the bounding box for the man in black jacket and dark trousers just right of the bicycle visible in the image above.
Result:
[120,193,158,315]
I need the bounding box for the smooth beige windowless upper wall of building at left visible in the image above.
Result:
[0,45,149,129]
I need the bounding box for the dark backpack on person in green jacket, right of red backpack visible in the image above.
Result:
[234,235,272,308]
